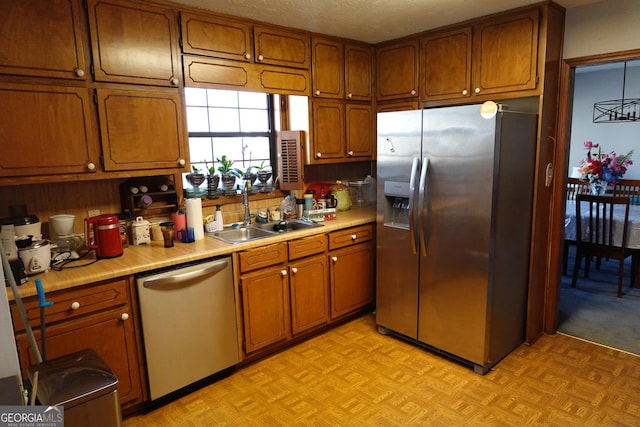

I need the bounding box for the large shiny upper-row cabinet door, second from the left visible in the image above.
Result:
[87,0,180,86]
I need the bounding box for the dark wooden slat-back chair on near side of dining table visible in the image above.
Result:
[571,194,637,298]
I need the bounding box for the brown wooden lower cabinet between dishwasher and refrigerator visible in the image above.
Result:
[238,225,374,358]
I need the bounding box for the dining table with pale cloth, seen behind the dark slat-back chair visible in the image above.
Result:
[564,200,640,249]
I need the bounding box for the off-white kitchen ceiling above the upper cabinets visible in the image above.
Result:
[173,0,604,43]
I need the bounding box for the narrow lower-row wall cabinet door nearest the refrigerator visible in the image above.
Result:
[346,103,374,160]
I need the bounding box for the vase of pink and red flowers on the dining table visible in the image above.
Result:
[578,141,633,196]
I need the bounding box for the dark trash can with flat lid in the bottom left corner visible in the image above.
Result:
[29,349,122,427]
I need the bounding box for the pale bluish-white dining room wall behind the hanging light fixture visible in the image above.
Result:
[569,67,640,179]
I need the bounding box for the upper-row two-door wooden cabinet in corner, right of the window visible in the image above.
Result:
[311,37,373,101]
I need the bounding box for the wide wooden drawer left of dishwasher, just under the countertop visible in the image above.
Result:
[11,279,128,332]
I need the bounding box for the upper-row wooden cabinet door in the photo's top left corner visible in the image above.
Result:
[0,0,87,80]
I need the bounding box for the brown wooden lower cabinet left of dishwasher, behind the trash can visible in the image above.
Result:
[11,279,144,413]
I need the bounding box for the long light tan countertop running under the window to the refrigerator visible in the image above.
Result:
[6,206,375,301]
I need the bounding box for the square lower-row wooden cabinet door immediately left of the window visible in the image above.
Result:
[97,89,185,170]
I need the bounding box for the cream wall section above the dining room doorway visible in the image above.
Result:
[563,0,640,58]
